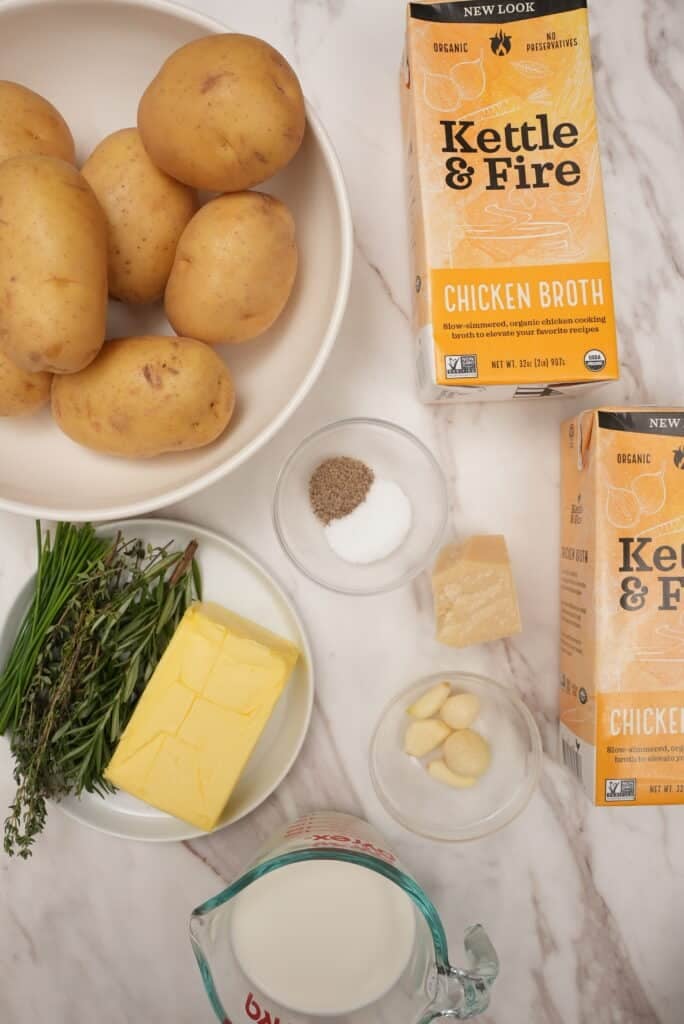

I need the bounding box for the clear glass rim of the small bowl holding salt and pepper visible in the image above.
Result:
[272,416,448,597]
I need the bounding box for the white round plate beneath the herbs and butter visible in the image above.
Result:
[0,519,313,842]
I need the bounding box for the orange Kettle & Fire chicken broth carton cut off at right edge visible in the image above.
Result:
[560,409,684,806]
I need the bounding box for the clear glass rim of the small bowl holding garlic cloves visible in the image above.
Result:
[369,669,544,843]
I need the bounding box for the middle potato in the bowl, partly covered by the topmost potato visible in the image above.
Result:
[81,128,198,303]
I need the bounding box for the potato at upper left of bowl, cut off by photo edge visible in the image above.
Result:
[0,82,76,164]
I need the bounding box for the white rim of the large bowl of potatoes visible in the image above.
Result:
[0,0,353,522]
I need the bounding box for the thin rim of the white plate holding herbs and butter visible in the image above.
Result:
[55,516,315,843]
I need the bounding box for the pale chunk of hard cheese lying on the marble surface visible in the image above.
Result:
[432,535,522,647]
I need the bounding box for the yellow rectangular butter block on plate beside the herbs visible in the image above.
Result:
[104,602,299,831]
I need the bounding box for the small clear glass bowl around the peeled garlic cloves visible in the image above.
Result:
[370,672,542,843]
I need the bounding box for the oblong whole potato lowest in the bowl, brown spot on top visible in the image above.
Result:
[52,335,234,459]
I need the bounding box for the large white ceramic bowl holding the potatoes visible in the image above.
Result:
[0,0,352,521]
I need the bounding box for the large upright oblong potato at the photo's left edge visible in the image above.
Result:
[0,157,106,374]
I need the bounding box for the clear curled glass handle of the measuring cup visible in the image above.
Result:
[420,925,499,1024]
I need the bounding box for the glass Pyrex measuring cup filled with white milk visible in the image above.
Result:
[190,811,499,1024]
